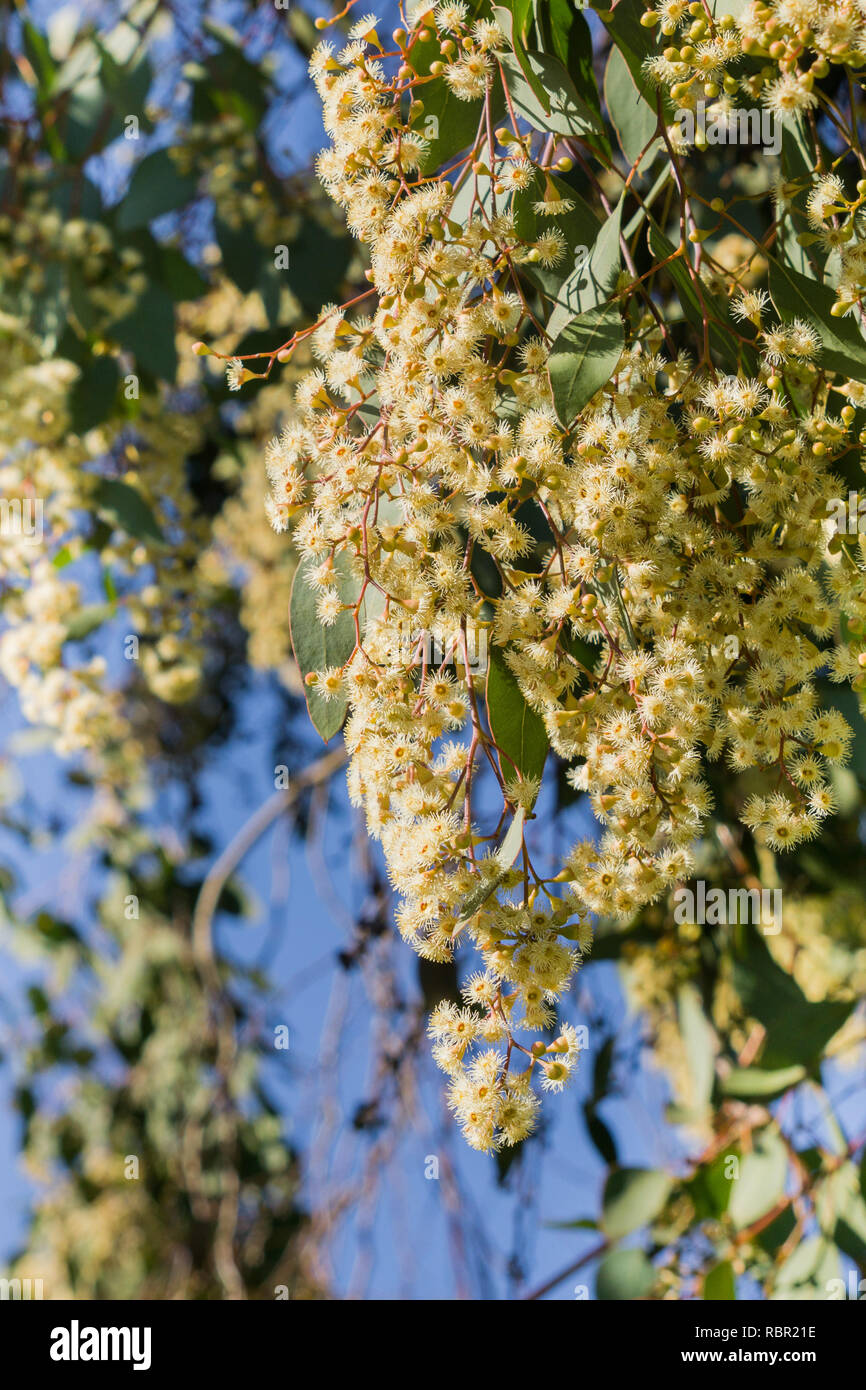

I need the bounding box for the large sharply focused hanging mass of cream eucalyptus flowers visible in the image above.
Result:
[267,6,862,1150]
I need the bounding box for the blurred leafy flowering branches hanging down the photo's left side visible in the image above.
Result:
[0,3,357,1298]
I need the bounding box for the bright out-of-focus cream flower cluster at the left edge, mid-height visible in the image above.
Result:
[0,320,203,771]
